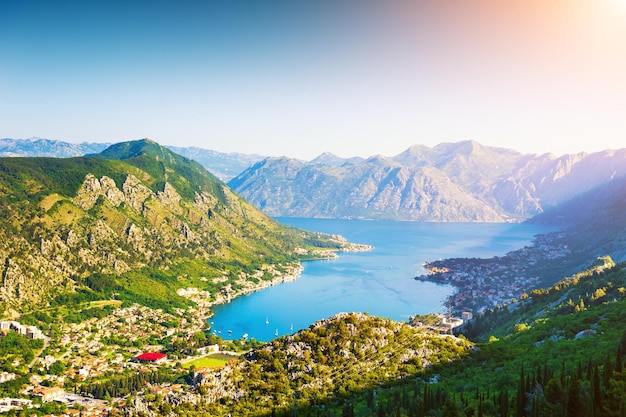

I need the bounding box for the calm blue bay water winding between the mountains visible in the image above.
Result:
[211,218,549,341]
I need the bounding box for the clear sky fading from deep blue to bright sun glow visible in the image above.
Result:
[0,0,626,159]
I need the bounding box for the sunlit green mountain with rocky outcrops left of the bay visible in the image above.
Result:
[0,140,336,310]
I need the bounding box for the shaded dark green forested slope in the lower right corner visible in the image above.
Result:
[312,258,626,417]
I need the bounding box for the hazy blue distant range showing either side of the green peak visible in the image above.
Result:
[0,138,264,181]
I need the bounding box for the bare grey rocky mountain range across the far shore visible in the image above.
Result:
[229,141,626,222]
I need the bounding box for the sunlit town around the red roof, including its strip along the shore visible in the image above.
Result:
[0,264,316,416]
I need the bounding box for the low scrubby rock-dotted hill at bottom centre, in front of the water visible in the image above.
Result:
[117,313,472,416]
